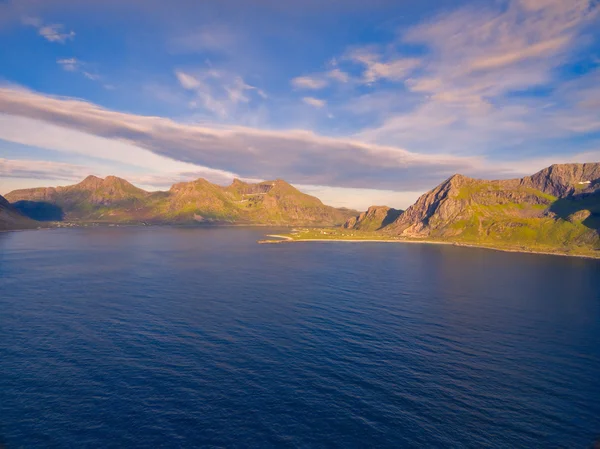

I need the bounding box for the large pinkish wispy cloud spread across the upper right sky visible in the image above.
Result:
[344,0,600,153]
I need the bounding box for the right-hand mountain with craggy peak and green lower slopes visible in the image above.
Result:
[381,164,600,254]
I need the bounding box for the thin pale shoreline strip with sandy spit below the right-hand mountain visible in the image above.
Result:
[258,235,600,260]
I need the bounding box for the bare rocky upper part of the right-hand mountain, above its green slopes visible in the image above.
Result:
[383,164,600,238]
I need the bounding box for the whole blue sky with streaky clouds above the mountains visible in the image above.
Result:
[0,0,600,209]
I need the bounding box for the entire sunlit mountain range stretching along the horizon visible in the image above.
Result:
[0,163,600,258]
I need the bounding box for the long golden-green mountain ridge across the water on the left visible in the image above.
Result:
[6,176,356,226]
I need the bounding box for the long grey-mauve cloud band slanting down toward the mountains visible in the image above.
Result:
[0,83,588,190]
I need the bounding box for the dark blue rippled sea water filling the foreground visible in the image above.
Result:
[0,228,600,448]
